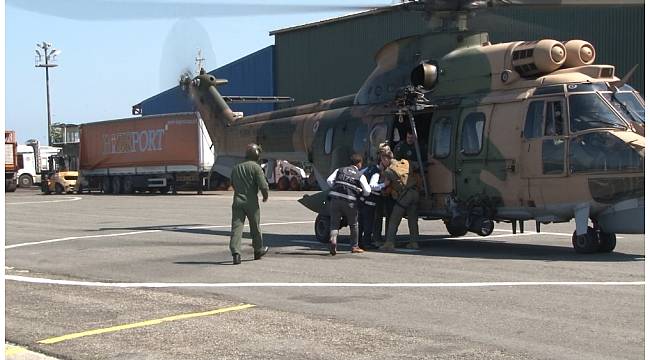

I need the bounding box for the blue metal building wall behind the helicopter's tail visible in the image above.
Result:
[139,45,276,115]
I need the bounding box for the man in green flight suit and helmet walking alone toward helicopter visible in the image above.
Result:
[230,144,269,265]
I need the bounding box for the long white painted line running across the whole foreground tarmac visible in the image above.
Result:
[5,275,645,288]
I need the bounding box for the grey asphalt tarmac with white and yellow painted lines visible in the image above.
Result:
[5,189,645,359]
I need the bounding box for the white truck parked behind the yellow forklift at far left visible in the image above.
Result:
[17,140,61,188]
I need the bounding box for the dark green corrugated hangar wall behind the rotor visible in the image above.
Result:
[275,6,645,105]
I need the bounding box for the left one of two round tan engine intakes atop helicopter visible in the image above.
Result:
[512,39,567,77]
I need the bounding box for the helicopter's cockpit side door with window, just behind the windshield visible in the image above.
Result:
[520,97,567,207]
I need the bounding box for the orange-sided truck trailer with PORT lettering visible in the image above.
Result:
[78,113,218,194]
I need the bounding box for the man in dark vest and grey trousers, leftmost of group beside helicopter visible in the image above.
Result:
[327,154,370,256]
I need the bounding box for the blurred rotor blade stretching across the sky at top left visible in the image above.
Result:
[6,0,390,20]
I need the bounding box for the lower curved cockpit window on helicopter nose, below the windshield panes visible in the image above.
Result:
[570,132,643,173]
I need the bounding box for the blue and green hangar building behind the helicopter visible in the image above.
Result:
[138,5,645,115]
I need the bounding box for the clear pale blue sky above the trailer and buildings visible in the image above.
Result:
[4,0,392,143]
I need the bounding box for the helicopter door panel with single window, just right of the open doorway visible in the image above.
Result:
[455,105,493,201]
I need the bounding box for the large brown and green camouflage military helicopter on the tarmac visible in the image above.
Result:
[181,0,645,253]
